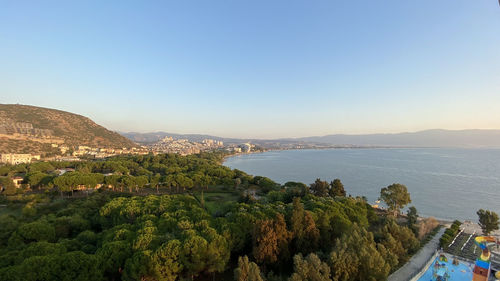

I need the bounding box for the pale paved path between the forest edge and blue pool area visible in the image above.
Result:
[387,227,446,281]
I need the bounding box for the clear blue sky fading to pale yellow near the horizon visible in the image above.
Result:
[0,0,500,138]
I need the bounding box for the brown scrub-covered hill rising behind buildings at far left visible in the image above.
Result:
[0,104,137,153]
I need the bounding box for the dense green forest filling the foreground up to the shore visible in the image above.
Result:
[0,153,436,281]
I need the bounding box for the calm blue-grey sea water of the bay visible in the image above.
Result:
[224,148,500,221]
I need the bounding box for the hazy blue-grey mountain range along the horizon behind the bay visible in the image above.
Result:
[121,129,500,148]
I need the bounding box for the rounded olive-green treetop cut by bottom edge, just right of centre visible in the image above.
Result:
[288,253,331,281]
